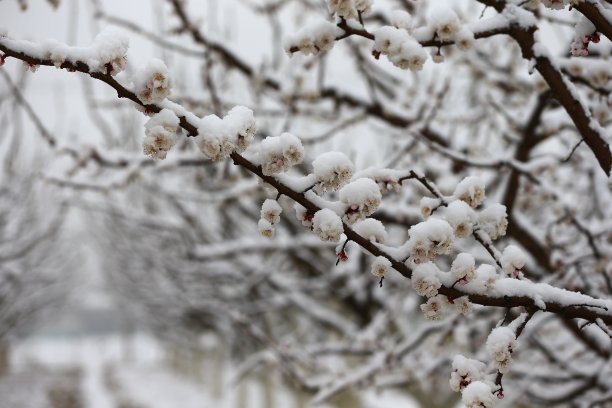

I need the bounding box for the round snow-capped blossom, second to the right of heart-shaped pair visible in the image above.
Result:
[312,152,354,192]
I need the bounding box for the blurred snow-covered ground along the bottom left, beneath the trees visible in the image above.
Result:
[0,334,414,408]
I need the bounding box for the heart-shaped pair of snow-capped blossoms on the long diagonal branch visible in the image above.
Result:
[195,106,257,160]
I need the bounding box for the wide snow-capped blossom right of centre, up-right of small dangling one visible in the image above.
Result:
[407,218,454,263]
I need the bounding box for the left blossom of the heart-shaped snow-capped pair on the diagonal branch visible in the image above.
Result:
[195,115,234,161]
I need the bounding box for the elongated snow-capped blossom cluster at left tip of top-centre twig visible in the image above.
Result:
[283,21,344,56]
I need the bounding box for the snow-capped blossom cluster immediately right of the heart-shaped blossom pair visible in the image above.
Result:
[259,133,304,176]
